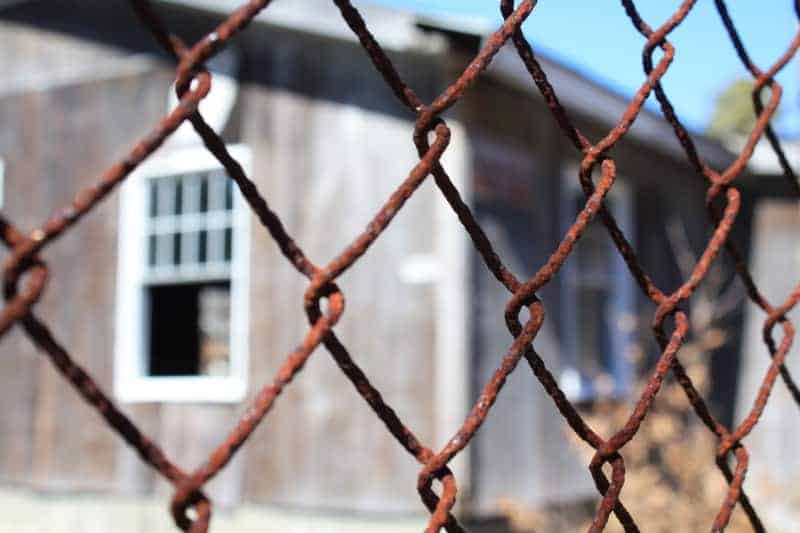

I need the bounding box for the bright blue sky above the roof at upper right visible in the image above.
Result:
[372,0,800,137]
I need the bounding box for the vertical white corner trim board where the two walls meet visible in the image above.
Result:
[428,122,474,498]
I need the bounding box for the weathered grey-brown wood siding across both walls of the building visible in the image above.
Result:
[0,4,748,514]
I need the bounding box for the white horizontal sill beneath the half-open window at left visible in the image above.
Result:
[116,376,247,403]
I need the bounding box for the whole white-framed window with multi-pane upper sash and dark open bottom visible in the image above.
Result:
[115,145,251,402]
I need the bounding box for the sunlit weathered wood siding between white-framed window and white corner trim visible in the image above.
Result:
[242,88,435,511]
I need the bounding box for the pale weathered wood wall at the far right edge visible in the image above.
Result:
[736,200,800,532]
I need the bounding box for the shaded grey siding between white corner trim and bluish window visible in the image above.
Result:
[471,132,591,513]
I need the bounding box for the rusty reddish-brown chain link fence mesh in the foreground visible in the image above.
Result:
[0,0,800,532]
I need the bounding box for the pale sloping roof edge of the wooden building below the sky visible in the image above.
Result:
[0,0,734,168]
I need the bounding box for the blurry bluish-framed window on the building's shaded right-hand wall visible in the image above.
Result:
[559,166,636,401]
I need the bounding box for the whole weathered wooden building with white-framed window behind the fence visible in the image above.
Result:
[0,0,780,528]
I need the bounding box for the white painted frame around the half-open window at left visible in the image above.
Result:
[114,145,252,402]
